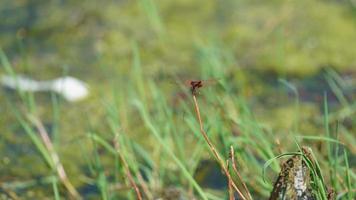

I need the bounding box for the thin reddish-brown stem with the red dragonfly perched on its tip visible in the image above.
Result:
[193,93,246,200]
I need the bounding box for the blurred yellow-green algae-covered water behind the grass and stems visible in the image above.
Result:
[0,0,356,199]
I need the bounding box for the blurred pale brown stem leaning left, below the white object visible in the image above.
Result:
[28,115,81,199]
